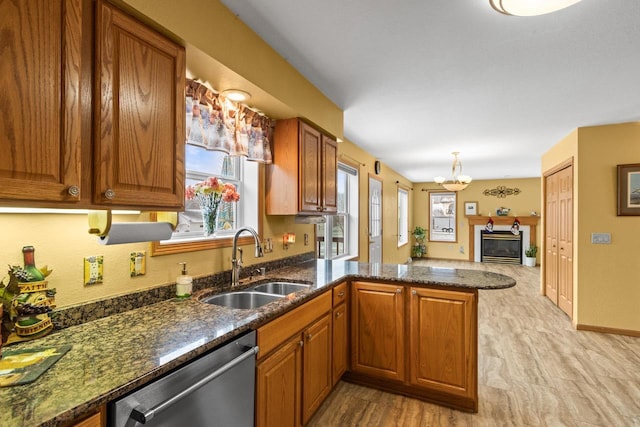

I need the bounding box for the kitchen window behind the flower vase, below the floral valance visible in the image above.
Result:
[152,144,259,255]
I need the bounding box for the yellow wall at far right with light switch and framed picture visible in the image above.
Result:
[574,122,640,331]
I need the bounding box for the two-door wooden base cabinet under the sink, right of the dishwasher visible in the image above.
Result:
[256,292,332,427]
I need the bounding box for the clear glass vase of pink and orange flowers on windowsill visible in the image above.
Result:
[185,177,240,236]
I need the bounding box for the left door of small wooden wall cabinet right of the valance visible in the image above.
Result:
[298,121,322,213]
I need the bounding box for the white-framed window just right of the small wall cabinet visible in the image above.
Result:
[316,163,358,259]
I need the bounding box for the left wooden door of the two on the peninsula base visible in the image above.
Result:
[351,282,405,380]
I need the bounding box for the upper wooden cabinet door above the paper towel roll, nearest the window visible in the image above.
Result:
[93,1,185,209]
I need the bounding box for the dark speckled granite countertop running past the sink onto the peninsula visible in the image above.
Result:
[0,260,516,427]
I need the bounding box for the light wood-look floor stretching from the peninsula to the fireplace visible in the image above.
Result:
[309,260,640,427]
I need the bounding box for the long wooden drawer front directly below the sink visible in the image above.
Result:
[258,292,331,359]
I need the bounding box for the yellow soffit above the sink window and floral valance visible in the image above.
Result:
[123,0,343,138]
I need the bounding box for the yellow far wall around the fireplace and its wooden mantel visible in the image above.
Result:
[412,178,541,260]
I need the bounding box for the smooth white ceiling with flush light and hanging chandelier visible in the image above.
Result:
[221,0,640,182]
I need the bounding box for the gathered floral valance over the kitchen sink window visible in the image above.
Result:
[186,79,275,163]
